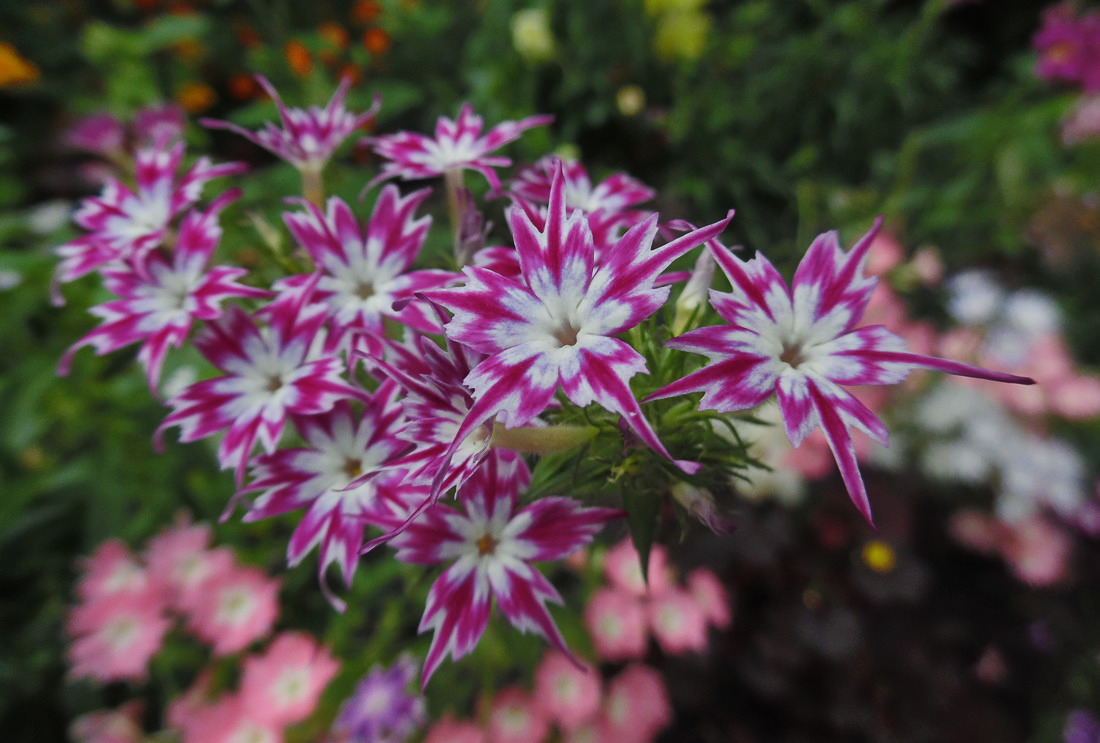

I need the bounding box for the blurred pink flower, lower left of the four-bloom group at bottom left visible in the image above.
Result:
[68,593,172,681]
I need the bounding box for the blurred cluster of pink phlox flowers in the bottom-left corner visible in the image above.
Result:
[69,523,339,743]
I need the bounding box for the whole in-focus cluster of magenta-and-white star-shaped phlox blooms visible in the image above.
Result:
[51,75,1031,682]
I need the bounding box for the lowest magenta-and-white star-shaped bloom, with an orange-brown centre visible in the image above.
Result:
[391,459,623,685]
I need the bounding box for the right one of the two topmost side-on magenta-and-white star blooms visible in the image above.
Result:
[366,103,553,192]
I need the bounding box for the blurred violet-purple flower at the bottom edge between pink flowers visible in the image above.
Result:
[329,656,422,743]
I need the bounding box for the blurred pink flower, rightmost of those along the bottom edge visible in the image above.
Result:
[600,663,672,743]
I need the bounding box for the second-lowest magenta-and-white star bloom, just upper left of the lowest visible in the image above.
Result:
[242,391,428,607]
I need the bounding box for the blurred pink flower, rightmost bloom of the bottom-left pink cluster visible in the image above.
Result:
[240,632,340,726]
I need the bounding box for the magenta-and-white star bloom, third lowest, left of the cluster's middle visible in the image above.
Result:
[157,286,363,484]
